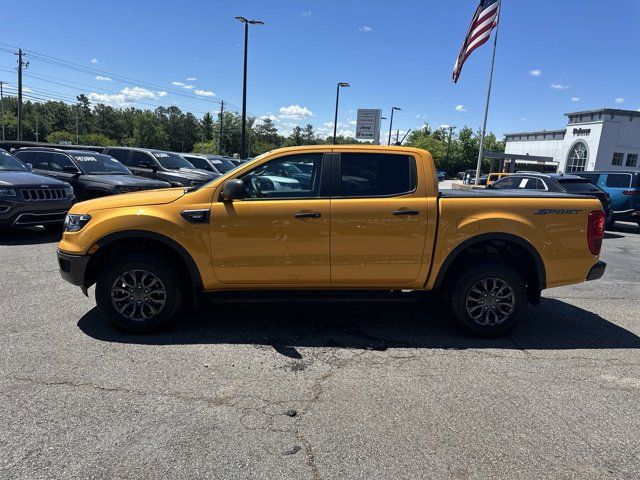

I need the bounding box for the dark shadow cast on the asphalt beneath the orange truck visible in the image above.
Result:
[78,299,640,352]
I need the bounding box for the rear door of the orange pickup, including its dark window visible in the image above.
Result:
[331,151,428,286]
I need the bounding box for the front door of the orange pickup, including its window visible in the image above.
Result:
[211,152,331,286]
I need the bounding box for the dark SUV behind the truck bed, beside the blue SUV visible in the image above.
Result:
[487,172,613,225]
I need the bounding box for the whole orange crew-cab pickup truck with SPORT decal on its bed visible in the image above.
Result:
[58,145,605,336]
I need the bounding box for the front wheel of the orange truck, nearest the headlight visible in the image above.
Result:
[96,255,182,333]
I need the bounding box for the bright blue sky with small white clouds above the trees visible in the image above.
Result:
[0,0,640,139]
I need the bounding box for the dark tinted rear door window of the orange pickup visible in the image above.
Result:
[339,153,417,197]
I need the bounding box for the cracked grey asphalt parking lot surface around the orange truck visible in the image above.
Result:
[0,224,640,480]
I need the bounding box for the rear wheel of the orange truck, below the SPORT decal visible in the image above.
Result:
[451,263,528,337]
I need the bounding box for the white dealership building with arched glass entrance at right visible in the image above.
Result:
[504,108,640,173]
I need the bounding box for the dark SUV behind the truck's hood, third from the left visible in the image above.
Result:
[103,147,214,187]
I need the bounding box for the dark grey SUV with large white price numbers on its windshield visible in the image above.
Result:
[15,147,170,201]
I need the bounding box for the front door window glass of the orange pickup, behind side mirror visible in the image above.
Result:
[240,153,324,198]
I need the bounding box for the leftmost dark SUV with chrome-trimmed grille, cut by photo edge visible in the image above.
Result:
[0,149,73,229]
